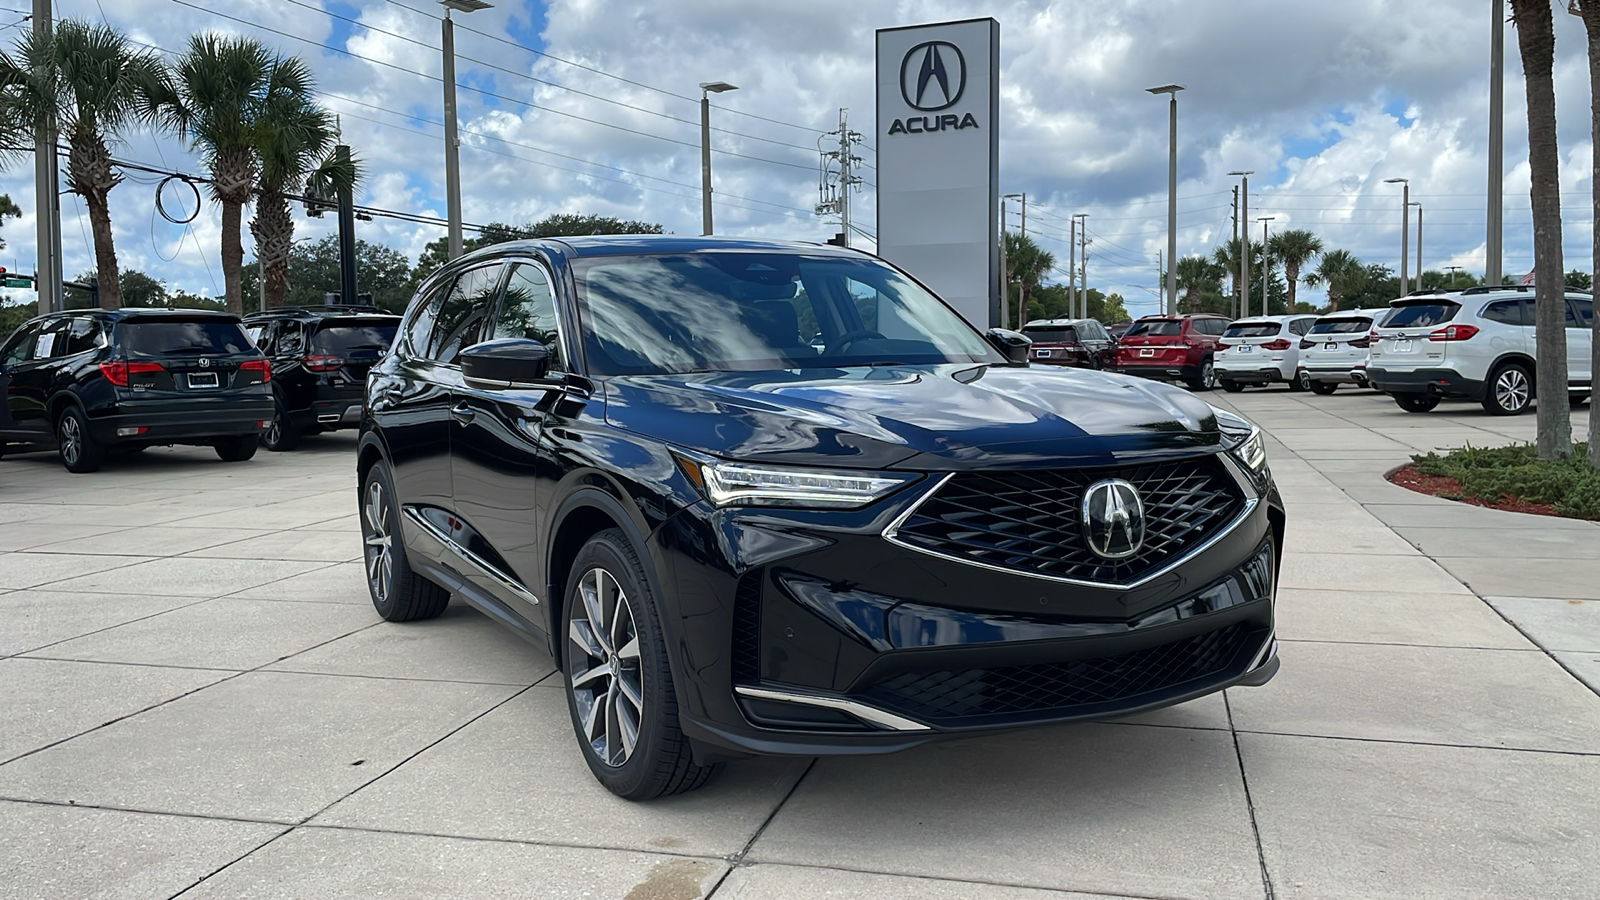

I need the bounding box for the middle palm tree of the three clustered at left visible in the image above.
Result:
[170,34,282,312]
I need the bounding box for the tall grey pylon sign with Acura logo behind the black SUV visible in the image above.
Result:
[877,19,1000,328]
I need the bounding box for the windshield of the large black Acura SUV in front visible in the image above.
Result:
[573,251,1002,375]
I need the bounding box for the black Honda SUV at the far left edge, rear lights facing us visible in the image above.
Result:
[0,309,272,472]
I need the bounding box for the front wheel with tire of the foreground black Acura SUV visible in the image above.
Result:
[562,528,718,801]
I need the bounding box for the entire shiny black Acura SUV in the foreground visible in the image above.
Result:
[358,237,1283,799]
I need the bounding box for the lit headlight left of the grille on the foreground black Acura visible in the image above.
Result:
[678,455,917,509]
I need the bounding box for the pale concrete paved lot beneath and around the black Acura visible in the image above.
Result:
[0,389,1600,900]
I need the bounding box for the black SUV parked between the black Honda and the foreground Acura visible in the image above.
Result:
[245,306,400,450]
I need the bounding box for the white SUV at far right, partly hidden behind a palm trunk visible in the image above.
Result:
[1366,287,1594,416]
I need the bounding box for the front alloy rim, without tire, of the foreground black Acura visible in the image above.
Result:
[566,565,645,769]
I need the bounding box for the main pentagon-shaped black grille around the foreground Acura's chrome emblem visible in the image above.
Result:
[894,456,1245,585]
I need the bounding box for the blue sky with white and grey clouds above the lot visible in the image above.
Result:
[0,0,1592,314]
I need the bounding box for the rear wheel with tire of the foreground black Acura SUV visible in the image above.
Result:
[360,461,450,621]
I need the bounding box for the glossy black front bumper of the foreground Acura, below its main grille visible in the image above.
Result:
[650,454,1283,759]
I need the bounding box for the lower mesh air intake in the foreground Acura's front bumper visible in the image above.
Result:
[864,621,1259,725]
